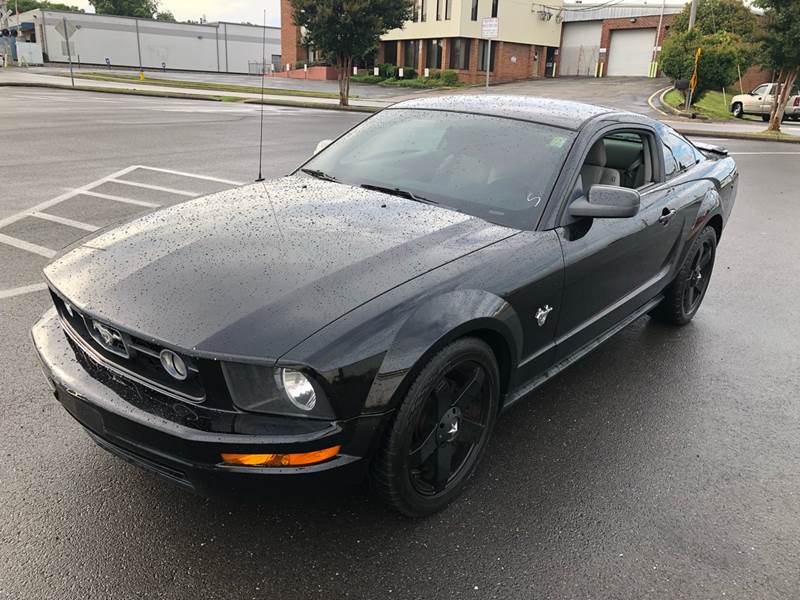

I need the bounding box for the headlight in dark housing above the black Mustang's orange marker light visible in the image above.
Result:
[222,363,335,419]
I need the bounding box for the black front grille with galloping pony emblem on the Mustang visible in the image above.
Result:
[51,290,221,403]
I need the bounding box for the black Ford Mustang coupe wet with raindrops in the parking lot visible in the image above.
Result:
[32,96,738,515]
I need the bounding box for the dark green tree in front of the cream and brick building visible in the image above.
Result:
[291,0,414,106]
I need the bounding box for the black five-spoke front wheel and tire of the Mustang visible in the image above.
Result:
[371,337,500,517]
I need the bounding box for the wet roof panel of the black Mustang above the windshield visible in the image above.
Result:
[390,94,620,131]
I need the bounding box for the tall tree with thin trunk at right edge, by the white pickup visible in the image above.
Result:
[756,0,800,131]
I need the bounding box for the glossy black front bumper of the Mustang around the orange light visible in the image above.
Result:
[31,309,389,496]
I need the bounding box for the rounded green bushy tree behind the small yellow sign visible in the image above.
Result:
[661,30,753,100]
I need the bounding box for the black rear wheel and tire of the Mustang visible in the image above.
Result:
[650,227,717,325]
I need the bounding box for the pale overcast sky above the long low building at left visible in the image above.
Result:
[70,0,281,25]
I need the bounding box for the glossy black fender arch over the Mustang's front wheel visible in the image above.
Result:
[365,289,522,410]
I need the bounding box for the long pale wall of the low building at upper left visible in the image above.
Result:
[21,10,281,73]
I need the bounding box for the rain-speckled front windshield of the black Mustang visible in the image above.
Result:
[301,109,574,228]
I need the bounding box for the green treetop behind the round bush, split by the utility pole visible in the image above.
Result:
[670,0,762,42]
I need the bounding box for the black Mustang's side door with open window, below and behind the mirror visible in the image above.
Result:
[556,126,681,360]
